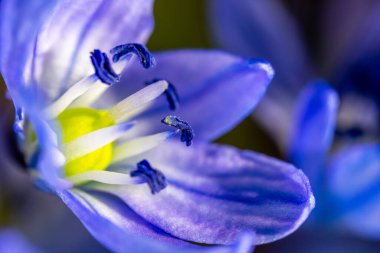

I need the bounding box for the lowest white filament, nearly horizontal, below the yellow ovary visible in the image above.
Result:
[66,170,145,185]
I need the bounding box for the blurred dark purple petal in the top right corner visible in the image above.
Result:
[320,0,380,78]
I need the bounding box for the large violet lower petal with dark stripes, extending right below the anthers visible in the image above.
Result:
[97,142,314,244]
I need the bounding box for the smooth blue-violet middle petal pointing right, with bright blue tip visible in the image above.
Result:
[104,50,273,140]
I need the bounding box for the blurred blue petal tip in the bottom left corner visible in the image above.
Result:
[0,229,42,253]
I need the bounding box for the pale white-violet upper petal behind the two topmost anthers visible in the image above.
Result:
[34,0,153,97]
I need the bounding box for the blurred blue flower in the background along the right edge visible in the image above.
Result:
[210,0,380,238]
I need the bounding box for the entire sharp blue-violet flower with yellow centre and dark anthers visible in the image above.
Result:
[0,0,314,252]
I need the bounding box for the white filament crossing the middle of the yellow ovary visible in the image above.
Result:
[63,122,135,162]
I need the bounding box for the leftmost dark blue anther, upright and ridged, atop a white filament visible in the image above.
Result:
[91,49,120,85]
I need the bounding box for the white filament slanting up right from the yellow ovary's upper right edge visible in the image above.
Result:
[109,81,169,122]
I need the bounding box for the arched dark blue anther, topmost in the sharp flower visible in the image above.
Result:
[110,43,156,69]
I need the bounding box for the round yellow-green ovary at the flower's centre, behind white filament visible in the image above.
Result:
[57,108,115,176]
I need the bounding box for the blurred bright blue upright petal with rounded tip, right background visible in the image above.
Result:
[288,81,339,190]
